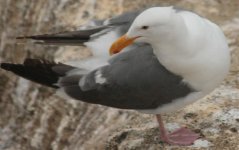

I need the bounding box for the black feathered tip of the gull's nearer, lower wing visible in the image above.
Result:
[0,58,74,88]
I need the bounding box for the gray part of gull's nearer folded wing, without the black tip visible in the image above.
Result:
[60,45,193,109]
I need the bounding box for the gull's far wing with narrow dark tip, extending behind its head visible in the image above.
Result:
[17,11,144,46]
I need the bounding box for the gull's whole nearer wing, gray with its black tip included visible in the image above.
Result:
[0,42,194,109]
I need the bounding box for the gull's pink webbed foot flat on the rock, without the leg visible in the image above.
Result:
[161,128,199,146]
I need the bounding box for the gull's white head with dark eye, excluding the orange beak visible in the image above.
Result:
[129,7,175,42]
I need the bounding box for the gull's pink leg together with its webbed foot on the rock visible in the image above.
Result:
[156,115,199,146]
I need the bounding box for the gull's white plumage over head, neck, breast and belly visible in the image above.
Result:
[120,7,230,114]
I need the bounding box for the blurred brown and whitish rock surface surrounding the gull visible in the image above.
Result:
[0,0,239,150]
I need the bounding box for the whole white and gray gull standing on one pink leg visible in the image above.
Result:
[1,6,231,145]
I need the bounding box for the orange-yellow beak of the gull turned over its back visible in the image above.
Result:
[110,35,139,55]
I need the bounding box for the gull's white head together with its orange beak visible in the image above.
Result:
[110,7,184,54]
